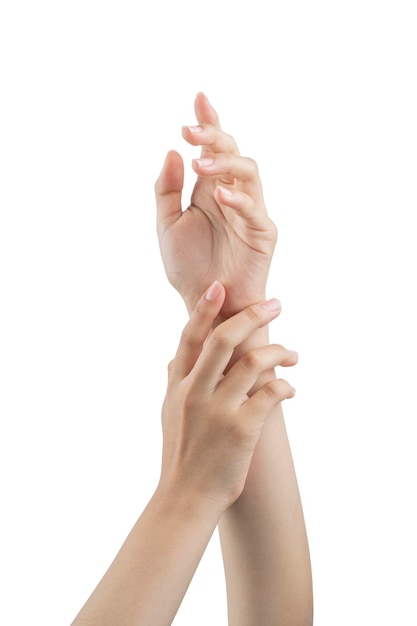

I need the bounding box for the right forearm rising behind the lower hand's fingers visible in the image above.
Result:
[219,336,313,626]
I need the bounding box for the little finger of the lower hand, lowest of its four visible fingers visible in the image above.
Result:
[240,378,295,429]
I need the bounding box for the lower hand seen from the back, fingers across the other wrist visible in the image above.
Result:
[158,281,297,511]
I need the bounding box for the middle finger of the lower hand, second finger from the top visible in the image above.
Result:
[194,299,281,390]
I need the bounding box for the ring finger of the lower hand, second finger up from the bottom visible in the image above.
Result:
[219,345,298,401]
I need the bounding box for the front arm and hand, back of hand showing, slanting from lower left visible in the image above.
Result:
[73,283,294,626]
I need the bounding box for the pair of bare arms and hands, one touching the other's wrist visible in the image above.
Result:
[73,94,312,626]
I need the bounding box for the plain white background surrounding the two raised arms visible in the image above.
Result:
[0,0,417,626]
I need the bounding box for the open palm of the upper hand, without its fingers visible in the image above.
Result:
[160,167,275,317]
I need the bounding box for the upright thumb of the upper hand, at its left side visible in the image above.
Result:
[155,150,184,232]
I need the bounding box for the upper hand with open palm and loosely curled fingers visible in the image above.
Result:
[155,93,277,318]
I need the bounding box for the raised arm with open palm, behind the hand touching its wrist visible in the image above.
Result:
[156,94,313,626]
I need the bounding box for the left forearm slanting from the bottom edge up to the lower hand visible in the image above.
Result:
[72,490,219,626]
